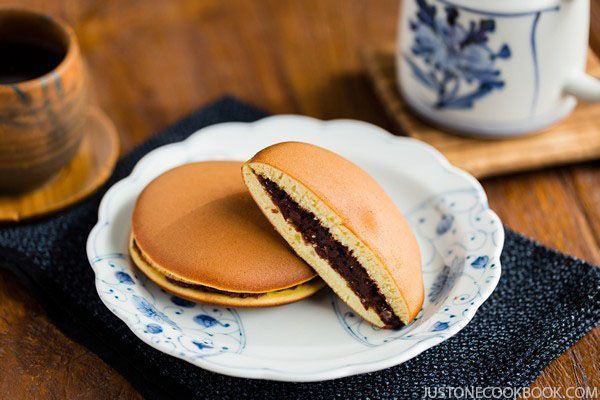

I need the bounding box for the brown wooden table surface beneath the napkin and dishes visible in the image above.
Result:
[0,0,600,399]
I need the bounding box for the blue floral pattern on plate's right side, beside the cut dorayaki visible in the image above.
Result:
[332,190,503,346]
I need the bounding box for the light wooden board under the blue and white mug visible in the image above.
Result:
[362,46,600,177]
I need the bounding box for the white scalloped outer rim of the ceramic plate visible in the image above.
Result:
[86,114,504,382]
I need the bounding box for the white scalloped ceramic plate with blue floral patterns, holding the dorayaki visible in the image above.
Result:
[87,115,504,381]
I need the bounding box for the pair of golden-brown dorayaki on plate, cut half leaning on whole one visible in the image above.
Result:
[129,142,424,328]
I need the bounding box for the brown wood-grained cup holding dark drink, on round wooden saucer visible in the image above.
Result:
[0,9,88,194]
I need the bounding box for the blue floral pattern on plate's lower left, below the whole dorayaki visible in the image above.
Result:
[93,254,246,358]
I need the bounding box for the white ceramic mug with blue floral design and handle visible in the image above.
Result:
[397,0,600,137]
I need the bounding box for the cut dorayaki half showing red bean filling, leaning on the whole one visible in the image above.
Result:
[242,142,424,328]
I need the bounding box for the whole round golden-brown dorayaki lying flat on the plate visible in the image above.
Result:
[129,161,323,307]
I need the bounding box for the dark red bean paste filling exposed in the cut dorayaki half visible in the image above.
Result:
[256,174,404,328]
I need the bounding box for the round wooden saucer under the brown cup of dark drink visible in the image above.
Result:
[0,108,119,222]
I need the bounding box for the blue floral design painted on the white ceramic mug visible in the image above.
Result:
[404,0,511,109]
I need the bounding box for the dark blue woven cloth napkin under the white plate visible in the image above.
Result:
[0,98,600,400]
